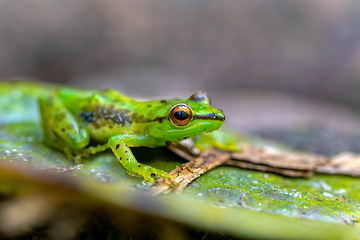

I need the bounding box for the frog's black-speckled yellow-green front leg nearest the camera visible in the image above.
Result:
[109,134,172,183]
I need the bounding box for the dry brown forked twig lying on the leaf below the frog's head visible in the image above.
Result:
[152,143,360,195]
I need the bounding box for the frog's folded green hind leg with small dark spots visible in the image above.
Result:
[39,96,90,159]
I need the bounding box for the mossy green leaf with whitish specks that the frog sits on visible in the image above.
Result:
[0,81,360,239]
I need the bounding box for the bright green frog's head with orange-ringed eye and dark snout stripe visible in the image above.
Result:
[146,92,225,141]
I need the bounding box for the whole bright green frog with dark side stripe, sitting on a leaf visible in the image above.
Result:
[39,85,225,183]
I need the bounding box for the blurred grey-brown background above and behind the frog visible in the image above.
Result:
[0,0,360,135]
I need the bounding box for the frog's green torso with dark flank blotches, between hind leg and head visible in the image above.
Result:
[57,88,139,142]
